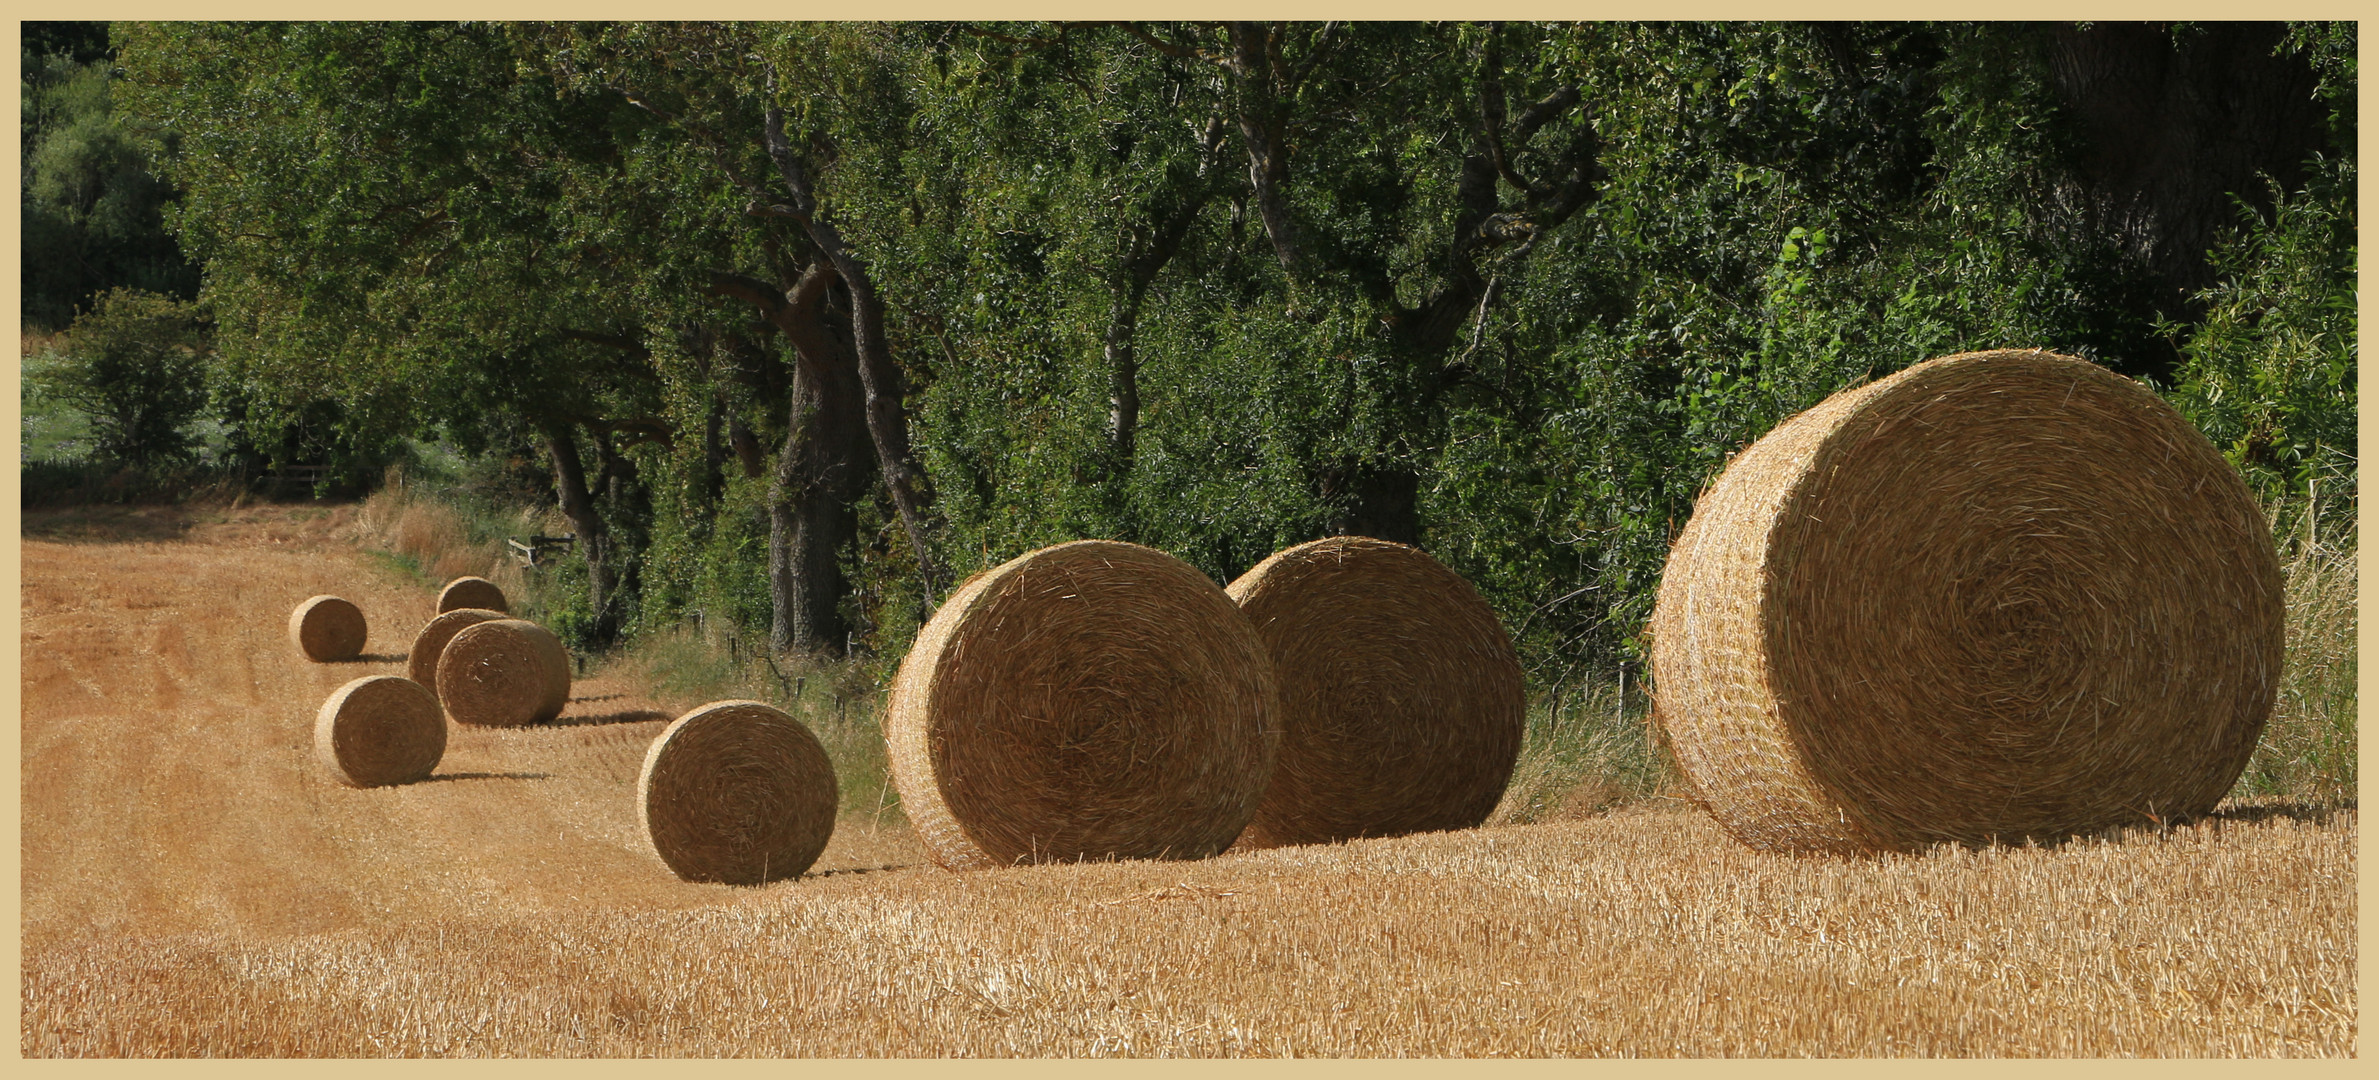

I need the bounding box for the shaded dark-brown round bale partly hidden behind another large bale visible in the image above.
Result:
[1228,535,1527,847]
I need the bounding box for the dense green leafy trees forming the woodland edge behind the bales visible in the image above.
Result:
[102,24,2355,692]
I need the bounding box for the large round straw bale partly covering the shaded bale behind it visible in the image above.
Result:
[885,540,1280,868]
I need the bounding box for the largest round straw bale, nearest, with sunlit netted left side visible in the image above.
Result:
[1651,350,2281,852]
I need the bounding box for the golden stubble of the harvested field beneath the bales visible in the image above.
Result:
[21,509,2358,1056]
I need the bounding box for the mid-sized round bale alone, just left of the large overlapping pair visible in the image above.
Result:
[635,702,840,885]
